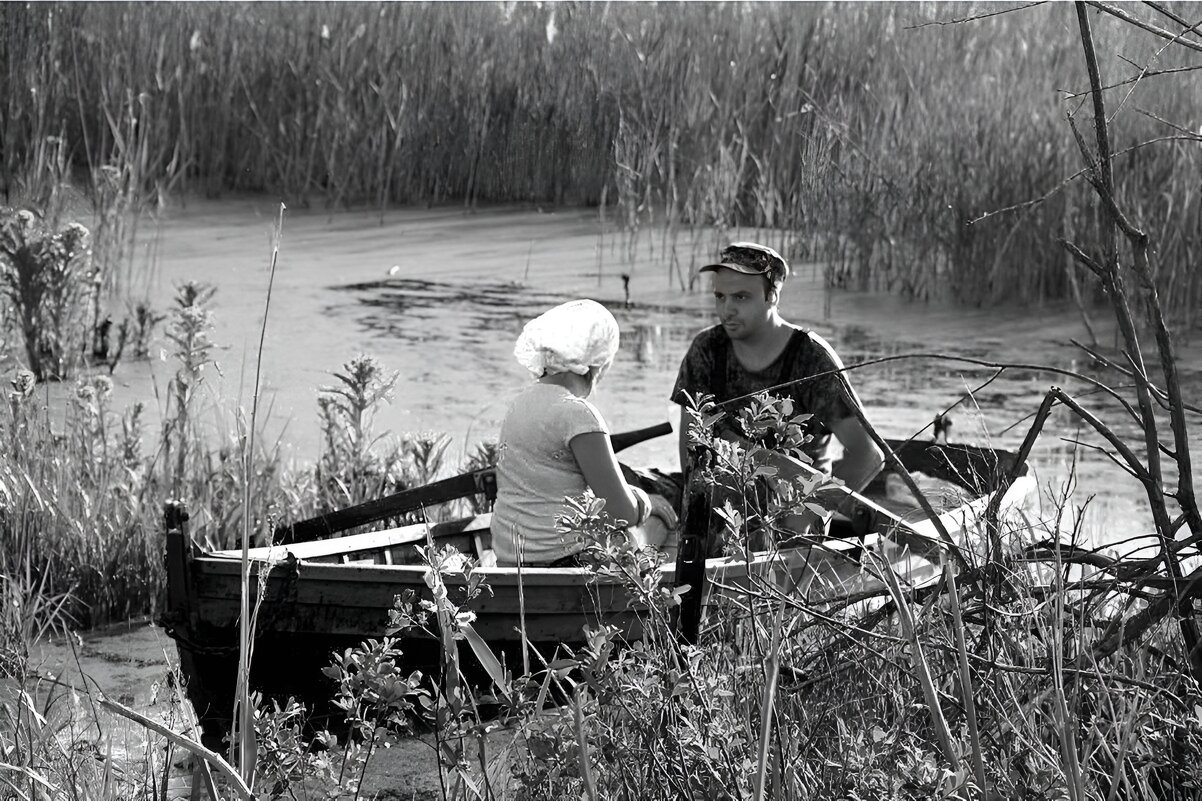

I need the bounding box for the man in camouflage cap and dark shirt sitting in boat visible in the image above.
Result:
[672,242,885,491]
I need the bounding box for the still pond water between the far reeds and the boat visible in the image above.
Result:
[98,198,1202,539]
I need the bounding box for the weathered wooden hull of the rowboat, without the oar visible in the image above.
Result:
[162,437,1033,740]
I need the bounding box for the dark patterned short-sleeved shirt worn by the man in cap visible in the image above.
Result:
[672,325,852,473]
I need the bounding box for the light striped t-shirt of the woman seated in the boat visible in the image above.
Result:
[493,384,609,565]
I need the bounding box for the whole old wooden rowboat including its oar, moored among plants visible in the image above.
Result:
[161,427,1034,732]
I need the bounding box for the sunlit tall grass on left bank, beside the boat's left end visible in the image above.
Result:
[0,284,466,627]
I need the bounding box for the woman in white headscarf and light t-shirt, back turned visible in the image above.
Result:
[493,301,676,566]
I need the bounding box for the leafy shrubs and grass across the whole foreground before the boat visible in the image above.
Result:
[7,370,1202,800]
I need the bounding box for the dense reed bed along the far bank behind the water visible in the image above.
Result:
[0,2,1202,322]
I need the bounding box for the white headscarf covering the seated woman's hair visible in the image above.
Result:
[513,301,618,378]
